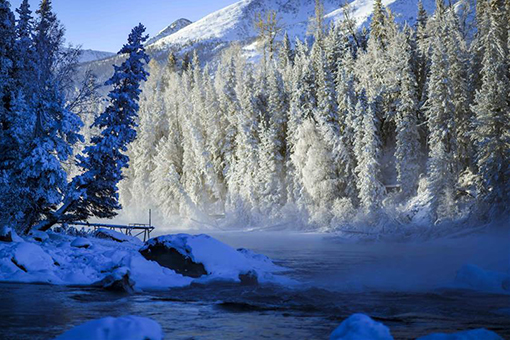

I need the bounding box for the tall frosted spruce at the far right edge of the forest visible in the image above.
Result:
[473,0,510,211]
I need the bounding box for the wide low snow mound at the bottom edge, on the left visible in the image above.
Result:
[55,315,164,340]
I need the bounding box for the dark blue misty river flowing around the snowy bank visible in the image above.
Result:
[0,233,510,340]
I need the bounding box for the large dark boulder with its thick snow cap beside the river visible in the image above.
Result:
[140,234,282,283]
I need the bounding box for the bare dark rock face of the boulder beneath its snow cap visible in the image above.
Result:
[140,238,208,278]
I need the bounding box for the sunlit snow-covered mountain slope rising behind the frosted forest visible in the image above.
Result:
[151,0,454,50]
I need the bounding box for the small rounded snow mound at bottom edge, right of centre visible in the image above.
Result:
[329,314,393,340]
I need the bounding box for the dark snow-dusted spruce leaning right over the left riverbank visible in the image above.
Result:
[37,24,149,231]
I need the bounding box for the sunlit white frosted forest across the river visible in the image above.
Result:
[120,0,510,230]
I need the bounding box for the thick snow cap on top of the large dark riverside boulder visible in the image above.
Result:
[140,234,283,282]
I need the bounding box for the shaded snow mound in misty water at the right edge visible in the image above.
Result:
[455,264,510,294]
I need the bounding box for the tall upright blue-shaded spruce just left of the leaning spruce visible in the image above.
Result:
[18,0,82,231]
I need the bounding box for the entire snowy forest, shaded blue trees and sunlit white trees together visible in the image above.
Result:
[0,0,510,235]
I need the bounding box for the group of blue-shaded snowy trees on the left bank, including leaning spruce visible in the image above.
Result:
[0,0,149,233]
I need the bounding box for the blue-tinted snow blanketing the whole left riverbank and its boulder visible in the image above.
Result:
[0,232,291,290]
